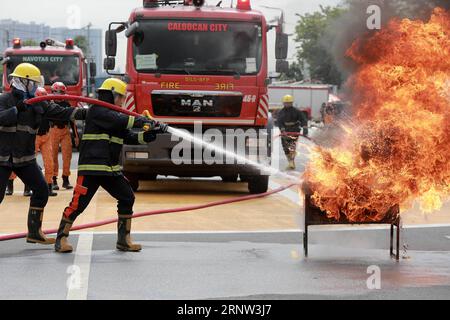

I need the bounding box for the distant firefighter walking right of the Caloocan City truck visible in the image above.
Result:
[277,95,308,170]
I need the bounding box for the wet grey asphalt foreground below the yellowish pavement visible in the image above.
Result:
[0,227,450,300]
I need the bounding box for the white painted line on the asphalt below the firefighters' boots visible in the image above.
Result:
[67,232,94,300]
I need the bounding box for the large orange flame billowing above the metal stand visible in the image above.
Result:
[305,8,450,222]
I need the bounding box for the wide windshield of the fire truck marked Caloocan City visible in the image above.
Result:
[133,20,262,75]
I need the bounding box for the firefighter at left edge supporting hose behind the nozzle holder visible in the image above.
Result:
[0,63,86,244]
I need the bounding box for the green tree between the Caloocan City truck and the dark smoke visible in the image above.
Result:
[295,6,345,85]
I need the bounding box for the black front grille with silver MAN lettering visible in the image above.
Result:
[151,91,243,118]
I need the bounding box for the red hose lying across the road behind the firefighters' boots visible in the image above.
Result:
[0,183,298,242]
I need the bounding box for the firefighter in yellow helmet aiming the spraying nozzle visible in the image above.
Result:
[55,78,168,253]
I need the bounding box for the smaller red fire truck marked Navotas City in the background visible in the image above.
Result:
[0,38,96,96]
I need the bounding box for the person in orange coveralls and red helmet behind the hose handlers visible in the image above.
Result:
[50,82,79,190]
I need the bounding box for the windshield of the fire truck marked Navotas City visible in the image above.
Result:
[7,54,81,86]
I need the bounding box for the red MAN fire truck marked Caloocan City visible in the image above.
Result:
[104,0,288,193]
